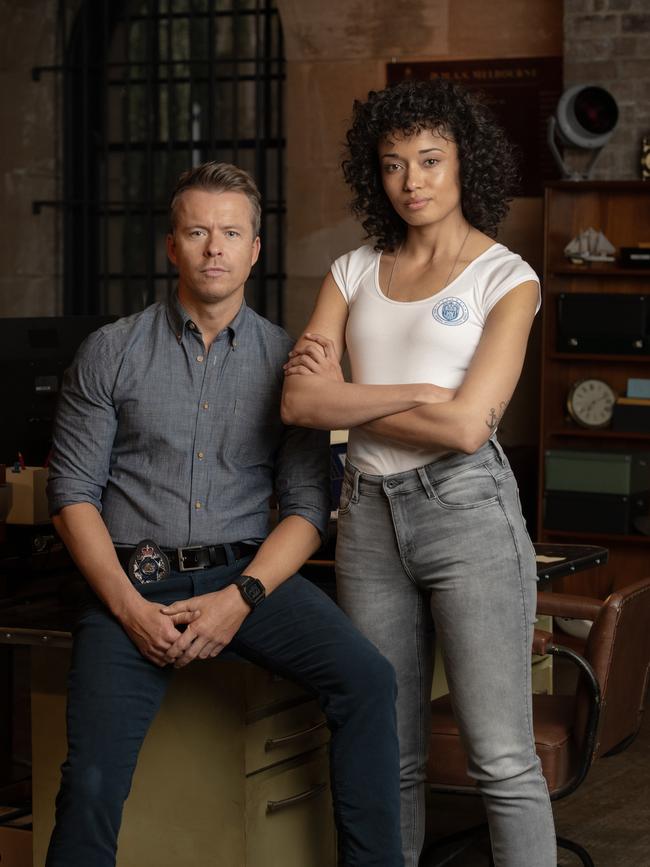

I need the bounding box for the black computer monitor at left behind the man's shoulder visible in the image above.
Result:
[0,316,116,466]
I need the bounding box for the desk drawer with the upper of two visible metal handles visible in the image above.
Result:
[246,701,329,774]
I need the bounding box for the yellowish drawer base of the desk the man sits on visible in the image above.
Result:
[32,647,336,867]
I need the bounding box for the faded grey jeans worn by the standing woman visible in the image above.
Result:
[336,440,557,867]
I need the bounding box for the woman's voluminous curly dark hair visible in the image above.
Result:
[342,78,519,250]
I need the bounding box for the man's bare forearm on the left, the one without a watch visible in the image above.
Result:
[52,503,142,621]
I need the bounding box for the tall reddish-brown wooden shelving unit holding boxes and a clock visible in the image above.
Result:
[537,181,650,597]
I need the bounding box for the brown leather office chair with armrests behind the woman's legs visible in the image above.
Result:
[420,578,650,867]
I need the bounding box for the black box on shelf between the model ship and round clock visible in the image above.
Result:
[557,292,650,355]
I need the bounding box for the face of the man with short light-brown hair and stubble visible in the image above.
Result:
[167,189,260,307]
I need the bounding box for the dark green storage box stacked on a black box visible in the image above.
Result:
[544,449,650,494]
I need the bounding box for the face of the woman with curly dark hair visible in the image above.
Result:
[378,130,461,226]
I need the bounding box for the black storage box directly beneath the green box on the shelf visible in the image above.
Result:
[544,491,650,535]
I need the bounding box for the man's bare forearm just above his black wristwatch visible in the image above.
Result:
[245,515,321,594]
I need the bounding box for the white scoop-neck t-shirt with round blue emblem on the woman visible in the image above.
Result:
[332,244,539,475]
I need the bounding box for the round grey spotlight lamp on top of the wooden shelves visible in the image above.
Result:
[547,84,618,181]
